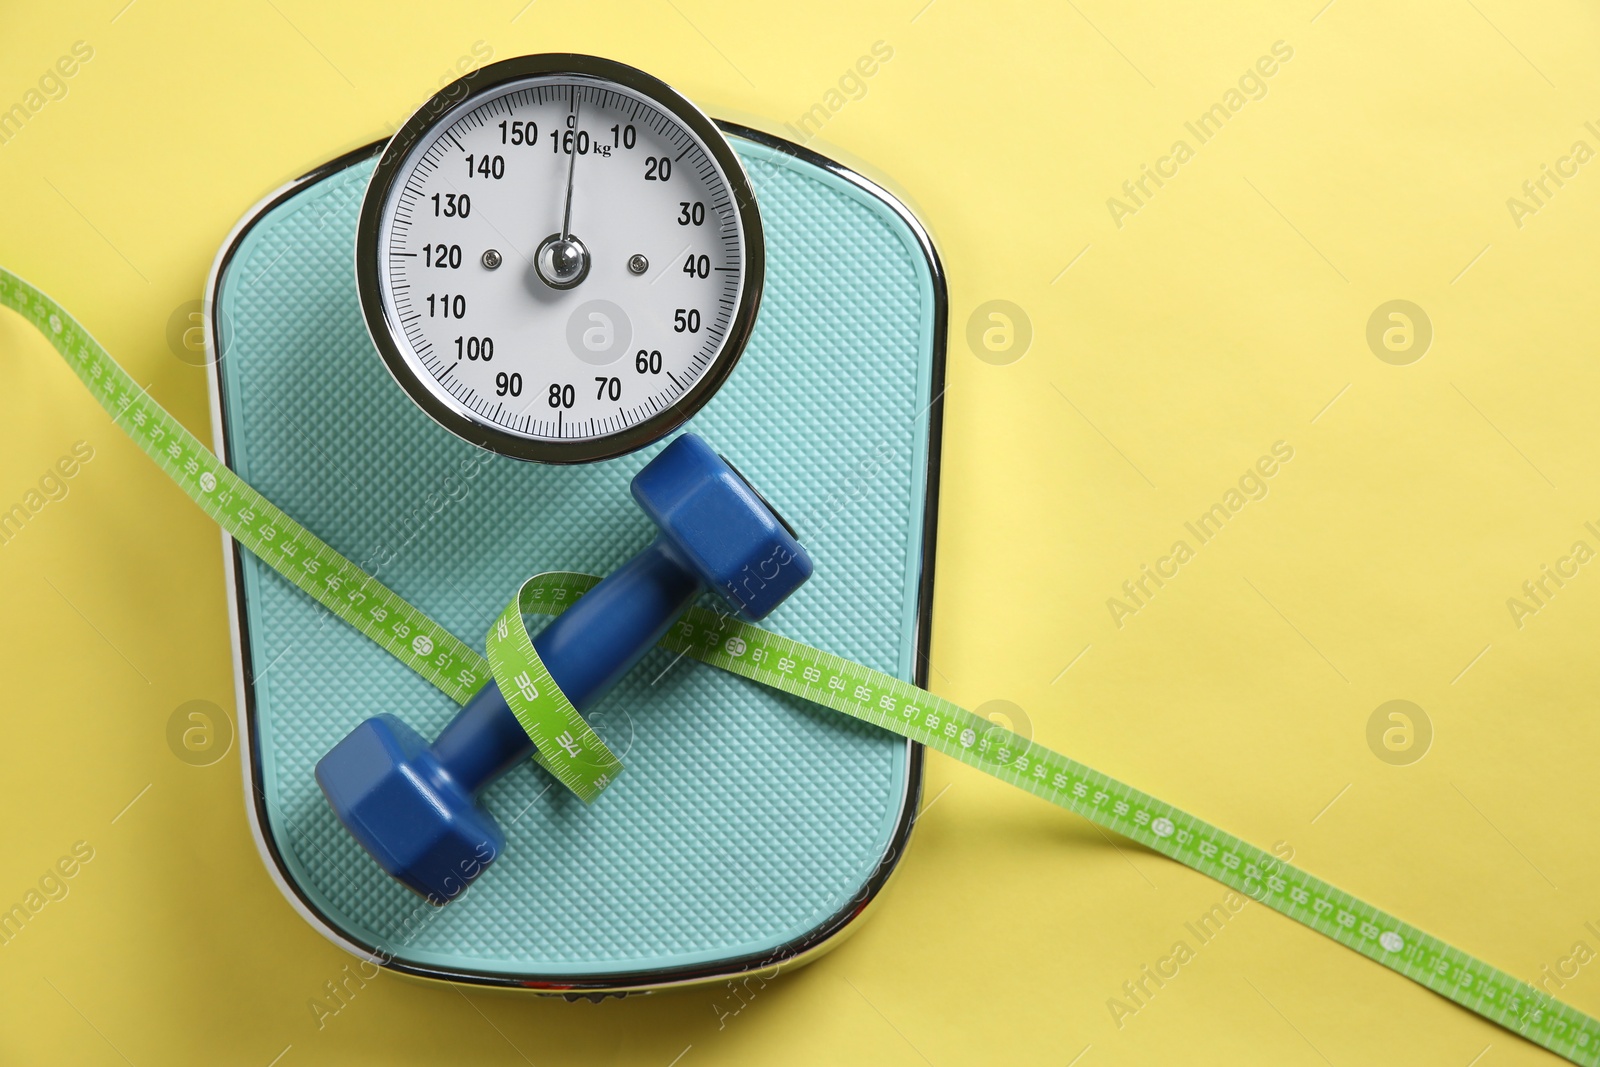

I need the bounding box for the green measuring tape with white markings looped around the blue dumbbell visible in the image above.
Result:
[0,260,1600,1067]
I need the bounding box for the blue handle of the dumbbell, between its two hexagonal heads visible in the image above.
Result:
[434,536,704,795]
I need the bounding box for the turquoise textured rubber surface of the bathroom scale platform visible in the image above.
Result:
[213,138,942,981]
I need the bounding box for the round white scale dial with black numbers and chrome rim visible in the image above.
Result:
[357,54,763,462]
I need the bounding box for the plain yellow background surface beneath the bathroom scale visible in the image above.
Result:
[0,0,1600,1067]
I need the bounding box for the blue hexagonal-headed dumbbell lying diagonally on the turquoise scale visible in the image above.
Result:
[317,434,811,904]
